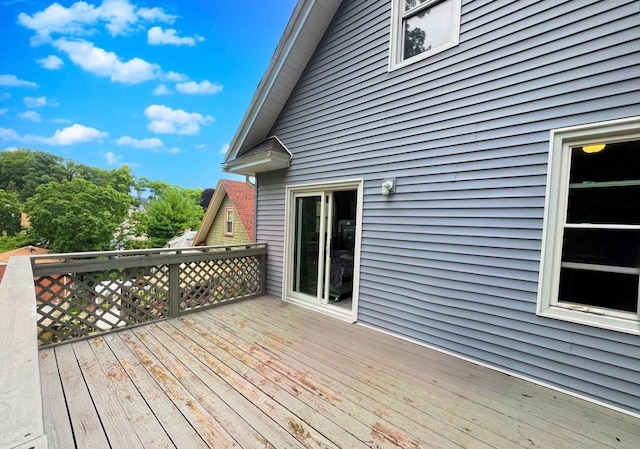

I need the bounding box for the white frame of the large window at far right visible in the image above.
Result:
[536,117,640,335]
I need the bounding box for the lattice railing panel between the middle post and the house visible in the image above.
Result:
[180,257,260,311]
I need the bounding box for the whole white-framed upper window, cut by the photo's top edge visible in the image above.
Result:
[389,0,461,70]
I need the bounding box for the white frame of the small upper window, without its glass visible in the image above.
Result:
[389,0,462,71]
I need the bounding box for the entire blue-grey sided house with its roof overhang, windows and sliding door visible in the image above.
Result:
[225,0,640,419]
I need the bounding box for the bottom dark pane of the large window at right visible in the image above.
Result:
[558,268,638,313]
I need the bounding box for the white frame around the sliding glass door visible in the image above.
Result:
[282,178,364,323]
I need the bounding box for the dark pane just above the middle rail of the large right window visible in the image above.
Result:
[567,184,640,224]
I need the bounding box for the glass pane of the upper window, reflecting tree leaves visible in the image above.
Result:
[402,1,452,59]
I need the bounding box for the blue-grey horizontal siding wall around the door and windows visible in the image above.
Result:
[257,0,640,413]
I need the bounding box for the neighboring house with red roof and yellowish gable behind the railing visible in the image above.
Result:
[193,179,256,246]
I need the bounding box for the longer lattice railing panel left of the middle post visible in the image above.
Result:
[35,265,169,346]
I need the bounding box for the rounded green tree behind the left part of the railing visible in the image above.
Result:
[25,178,131,252]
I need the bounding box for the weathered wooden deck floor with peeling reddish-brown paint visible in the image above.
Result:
[40,297,640,449]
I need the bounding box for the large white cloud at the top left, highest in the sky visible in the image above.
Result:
[18,0,177,45]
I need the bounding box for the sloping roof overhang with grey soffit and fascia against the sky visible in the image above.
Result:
[224,0,341,165]
